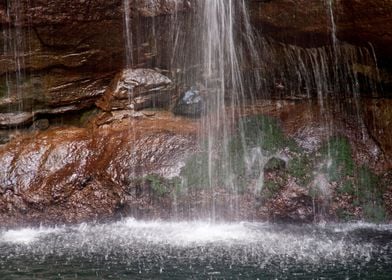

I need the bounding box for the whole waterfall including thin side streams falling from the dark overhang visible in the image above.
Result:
[116,0,382,219]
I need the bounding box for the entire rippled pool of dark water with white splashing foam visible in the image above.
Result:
[0,218,392,279]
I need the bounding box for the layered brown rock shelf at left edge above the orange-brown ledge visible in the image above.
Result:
[0,71,113,113]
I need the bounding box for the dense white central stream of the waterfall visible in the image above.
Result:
[193,0,258,218]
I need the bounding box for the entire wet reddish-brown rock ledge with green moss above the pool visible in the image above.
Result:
[0,101,392,226]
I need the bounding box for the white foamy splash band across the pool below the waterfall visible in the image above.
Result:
[0,218,392,263]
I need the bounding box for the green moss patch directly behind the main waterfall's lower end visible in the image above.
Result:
[180,115,304,191]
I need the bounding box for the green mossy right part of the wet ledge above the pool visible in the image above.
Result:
[127,115,391,223]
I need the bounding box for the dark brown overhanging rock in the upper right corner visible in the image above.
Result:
[249,0,392,98]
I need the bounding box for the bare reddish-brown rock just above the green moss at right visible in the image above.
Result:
[268,98,391,171]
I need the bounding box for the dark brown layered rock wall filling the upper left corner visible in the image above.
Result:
[0,0,124,125]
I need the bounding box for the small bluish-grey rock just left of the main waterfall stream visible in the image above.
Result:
[174,88,205,117]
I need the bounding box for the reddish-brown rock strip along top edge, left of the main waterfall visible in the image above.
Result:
[0,0,191,25]
